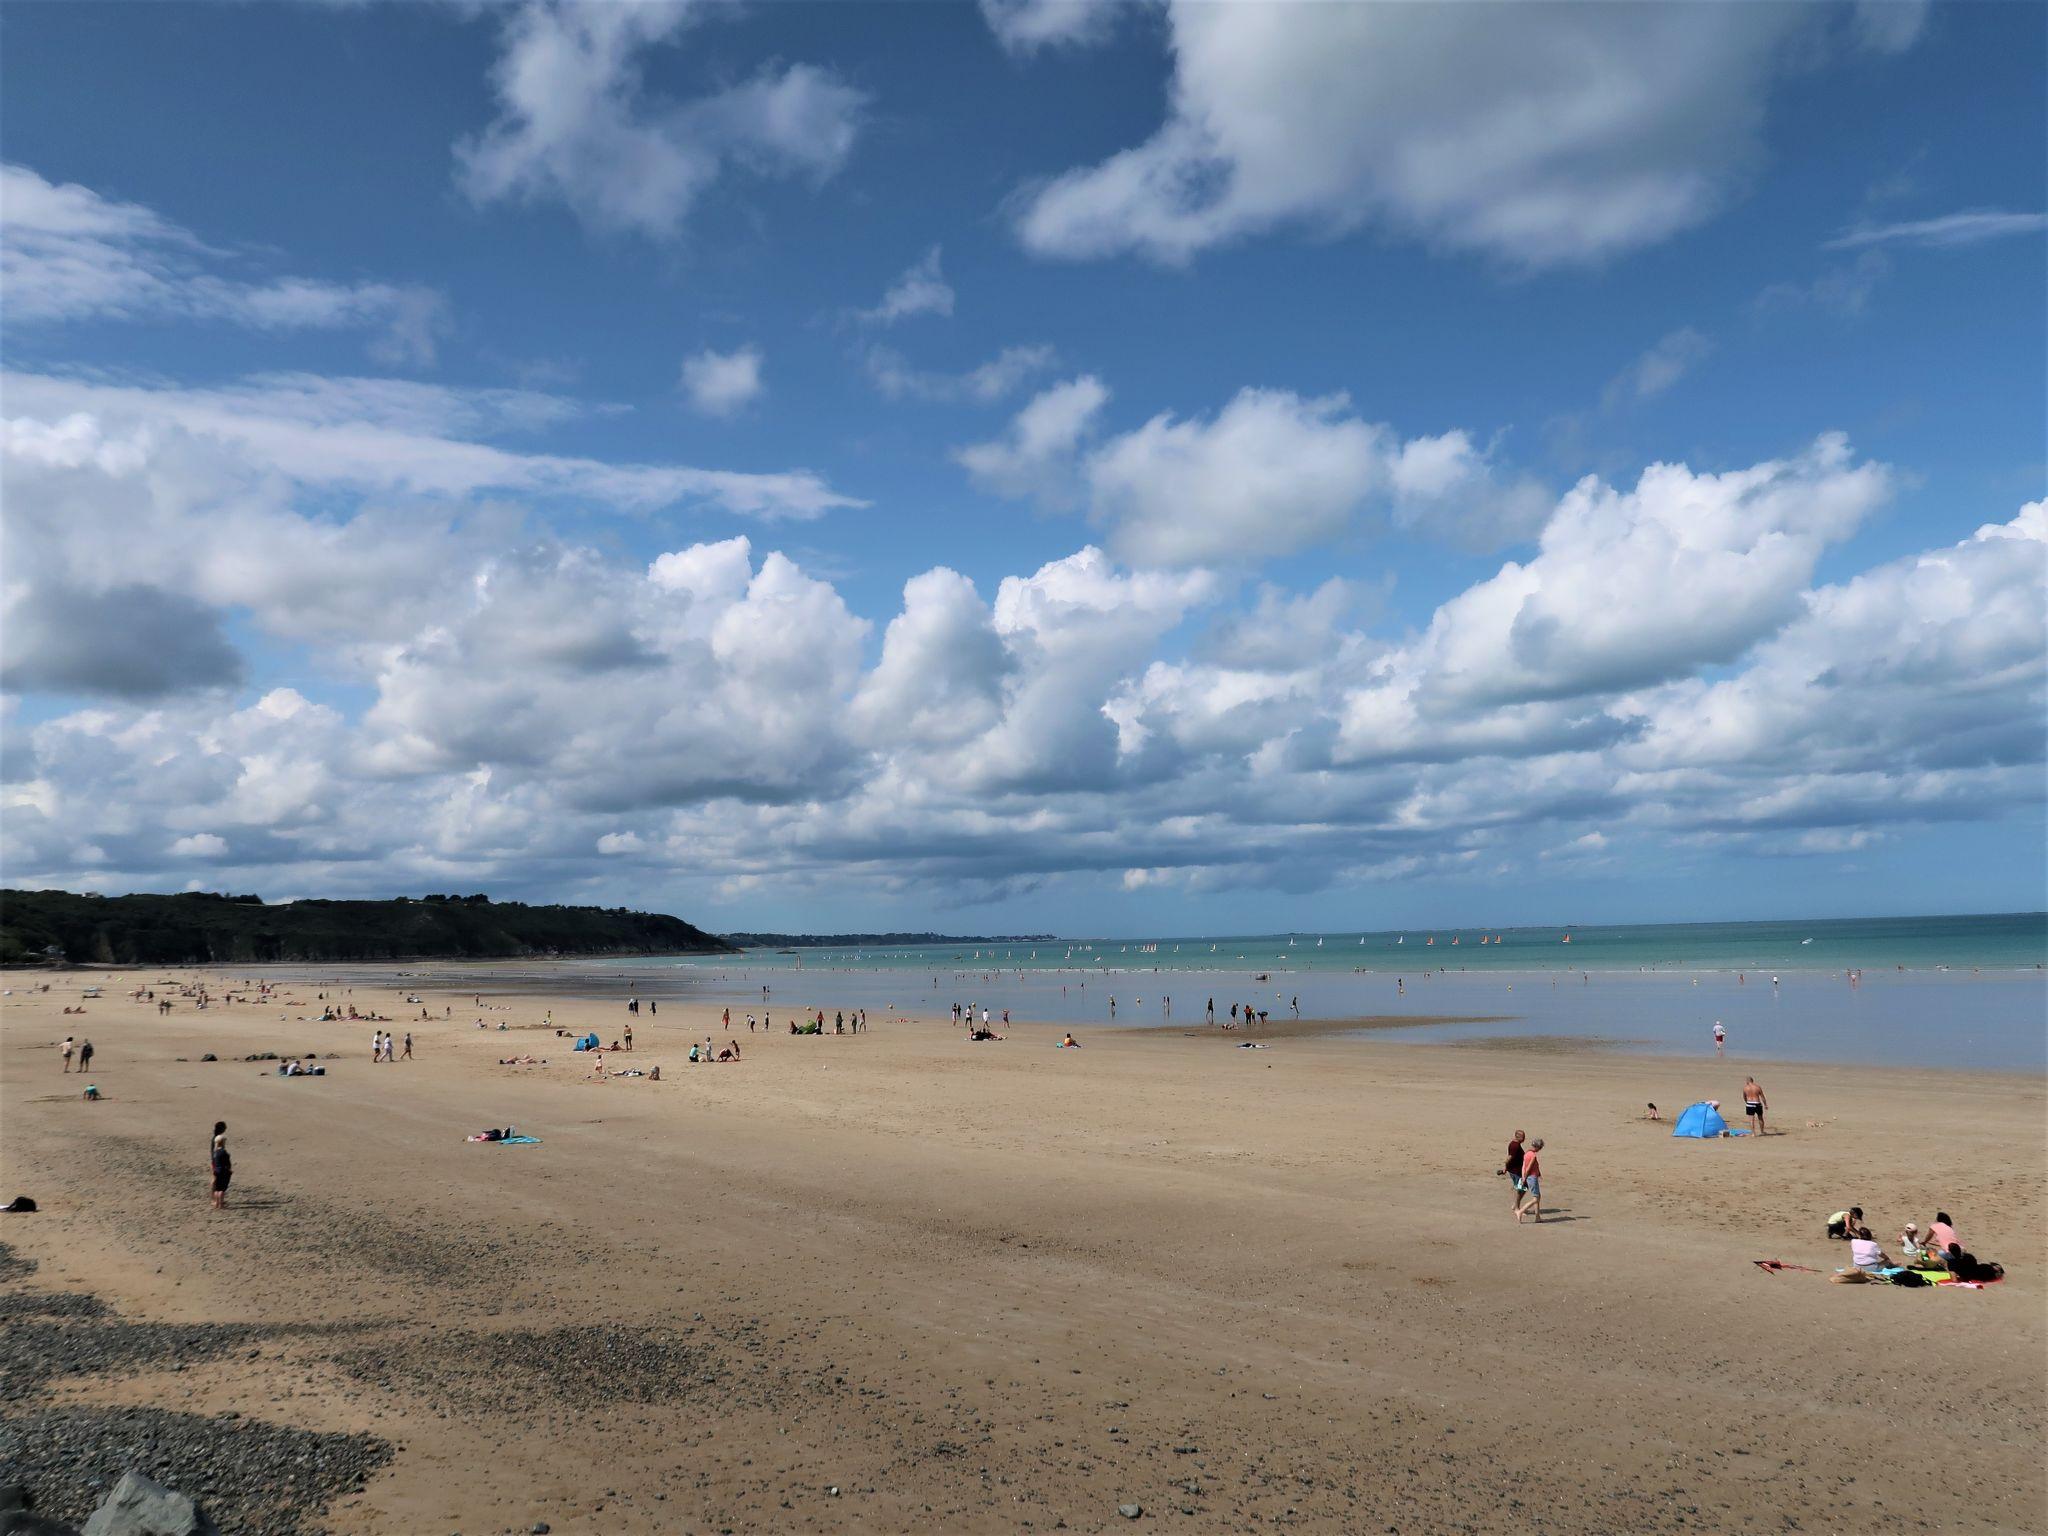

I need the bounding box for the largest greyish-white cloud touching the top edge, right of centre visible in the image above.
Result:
[1018,0,1917,266]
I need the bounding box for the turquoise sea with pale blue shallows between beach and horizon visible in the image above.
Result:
[614,913,2048,1073]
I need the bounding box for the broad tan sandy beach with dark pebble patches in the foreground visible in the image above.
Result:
[0,967,2048,1536]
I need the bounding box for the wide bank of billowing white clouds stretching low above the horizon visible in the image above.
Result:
[0,385,2048,907]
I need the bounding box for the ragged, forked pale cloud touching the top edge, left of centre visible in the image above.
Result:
[457,0,866,240]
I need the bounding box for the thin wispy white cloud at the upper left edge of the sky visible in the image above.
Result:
[0,166,446,367]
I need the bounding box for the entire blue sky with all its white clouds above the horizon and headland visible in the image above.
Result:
[0,0,2048,932]
